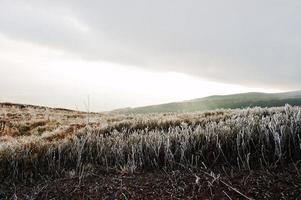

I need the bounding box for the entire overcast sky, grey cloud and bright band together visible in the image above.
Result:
[0,0,301,111]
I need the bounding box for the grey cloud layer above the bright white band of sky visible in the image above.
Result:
[0,0,301,89]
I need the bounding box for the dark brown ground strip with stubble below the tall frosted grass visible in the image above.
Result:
[0,166,301,200]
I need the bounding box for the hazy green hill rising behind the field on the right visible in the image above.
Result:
[112,91,301,113]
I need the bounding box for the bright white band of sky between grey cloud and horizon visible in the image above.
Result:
[0,35,278,111]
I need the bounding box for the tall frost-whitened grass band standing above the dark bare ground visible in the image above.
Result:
[0,105,301,180]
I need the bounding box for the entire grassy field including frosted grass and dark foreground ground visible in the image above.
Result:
[0,104,301,199]
